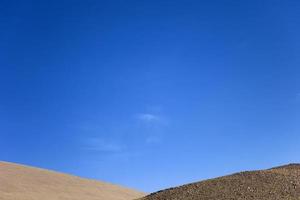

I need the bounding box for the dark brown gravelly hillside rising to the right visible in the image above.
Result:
[140,164,300,200]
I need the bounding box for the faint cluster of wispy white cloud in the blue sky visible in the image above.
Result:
[80,108,168,159]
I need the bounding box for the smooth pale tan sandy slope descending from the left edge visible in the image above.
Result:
[0,162,144,200]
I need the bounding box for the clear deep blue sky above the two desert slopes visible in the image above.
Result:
[0,0,300,192]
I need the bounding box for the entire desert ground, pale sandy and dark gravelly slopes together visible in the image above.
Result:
[0,162,300,200]
